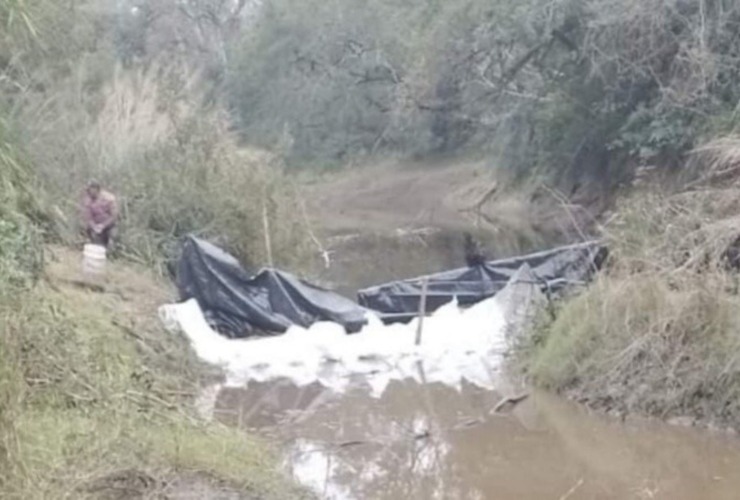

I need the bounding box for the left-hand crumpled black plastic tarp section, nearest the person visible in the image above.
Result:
[177,236,365,338]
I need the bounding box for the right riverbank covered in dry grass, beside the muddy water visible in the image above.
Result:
[517,171,740,431]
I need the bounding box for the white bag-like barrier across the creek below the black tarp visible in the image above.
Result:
[159,266,544,397]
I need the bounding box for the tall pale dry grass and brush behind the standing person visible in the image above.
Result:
[24,65,308,267]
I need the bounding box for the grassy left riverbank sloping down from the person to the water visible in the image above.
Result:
[0,247,303,500]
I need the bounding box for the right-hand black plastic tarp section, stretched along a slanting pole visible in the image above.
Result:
[358,241,607,322]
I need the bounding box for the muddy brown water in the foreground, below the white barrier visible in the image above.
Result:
[205,382,740,500]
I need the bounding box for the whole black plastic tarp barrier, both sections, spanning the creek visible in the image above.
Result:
[176,236,607,338]
